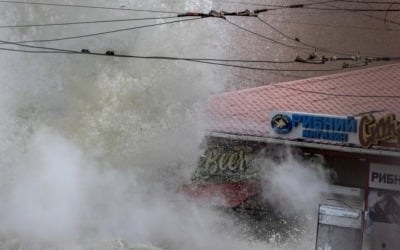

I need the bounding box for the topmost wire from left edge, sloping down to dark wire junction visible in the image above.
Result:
[0,0,181,14]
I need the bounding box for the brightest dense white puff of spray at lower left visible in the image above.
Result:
[2,128,82,239]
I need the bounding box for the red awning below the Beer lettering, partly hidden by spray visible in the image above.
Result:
[183,182,261,207]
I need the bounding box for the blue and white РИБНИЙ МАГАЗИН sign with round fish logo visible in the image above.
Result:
[270,111,358,144]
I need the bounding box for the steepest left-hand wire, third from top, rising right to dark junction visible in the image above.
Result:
[0,17,201,44]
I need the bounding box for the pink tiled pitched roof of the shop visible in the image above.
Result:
[208,63,400,137]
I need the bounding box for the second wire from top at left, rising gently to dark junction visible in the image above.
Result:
[0,16,177,28]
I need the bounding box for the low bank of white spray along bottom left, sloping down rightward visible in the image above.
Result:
[0,129,288,249]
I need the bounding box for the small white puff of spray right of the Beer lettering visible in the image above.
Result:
[263,150,329,218]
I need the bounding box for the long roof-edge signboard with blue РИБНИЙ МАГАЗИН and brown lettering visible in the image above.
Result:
[270,111,400,148]
